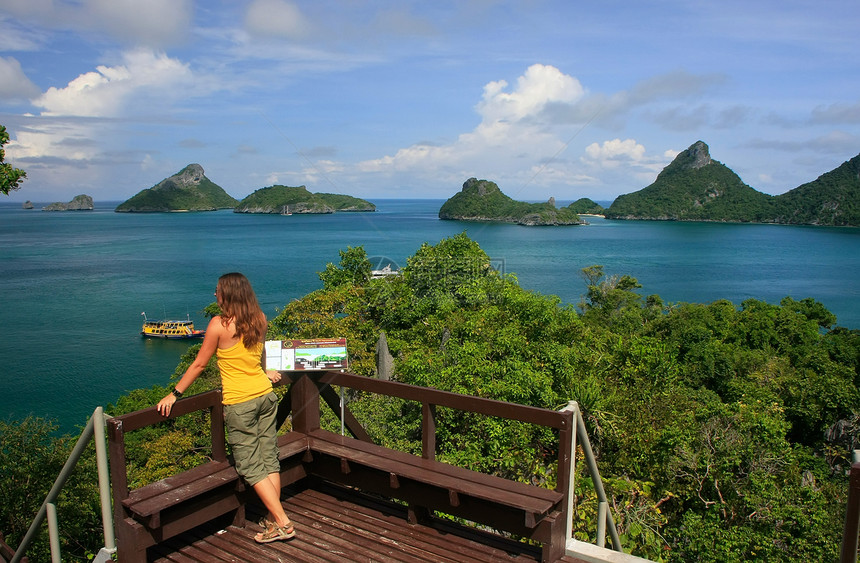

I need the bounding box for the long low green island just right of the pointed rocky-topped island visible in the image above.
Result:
[233,184,376,215]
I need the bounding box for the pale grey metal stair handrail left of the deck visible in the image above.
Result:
[10,407,116,563]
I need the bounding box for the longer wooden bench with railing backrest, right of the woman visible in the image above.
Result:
[282,372,573,562]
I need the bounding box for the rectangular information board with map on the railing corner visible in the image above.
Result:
[265,338,347,371]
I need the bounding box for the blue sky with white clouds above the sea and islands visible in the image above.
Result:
[0,0,860,202]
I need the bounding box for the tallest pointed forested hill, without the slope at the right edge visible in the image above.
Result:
[605,141,773,221]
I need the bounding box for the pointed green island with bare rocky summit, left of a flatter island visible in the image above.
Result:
[115,164,237,213]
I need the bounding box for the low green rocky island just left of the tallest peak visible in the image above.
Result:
[439,178,596,226]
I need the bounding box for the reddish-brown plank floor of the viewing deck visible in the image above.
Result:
[148,485,580,563]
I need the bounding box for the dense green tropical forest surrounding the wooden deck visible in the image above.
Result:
[0,233,860,562]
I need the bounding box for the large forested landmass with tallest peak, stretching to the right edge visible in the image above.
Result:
[605,141,860,226]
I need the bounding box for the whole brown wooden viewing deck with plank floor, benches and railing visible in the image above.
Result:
[107,372,592,563]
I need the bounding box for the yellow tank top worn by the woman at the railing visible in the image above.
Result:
[215,340,272,405]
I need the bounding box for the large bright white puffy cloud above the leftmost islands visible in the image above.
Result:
[33,49,192,117]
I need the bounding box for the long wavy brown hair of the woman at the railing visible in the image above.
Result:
[216,272,268,347]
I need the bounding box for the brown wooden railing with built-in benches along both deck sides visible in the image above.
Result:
[108,371,574,563]
